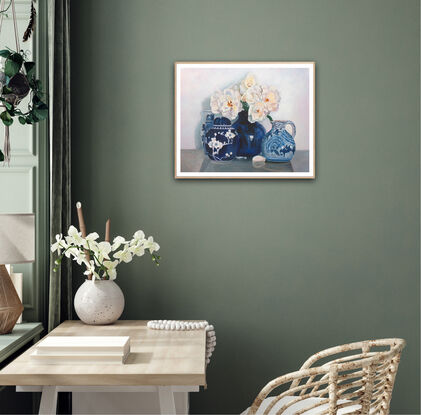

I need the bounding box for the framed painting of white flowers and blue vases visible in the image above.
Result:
[175,62,315,179]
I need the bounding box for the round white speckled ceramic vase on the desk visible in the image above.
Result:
[74,280,124,325]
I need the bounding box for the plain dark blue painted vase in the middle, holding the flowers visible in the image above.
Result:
[232,111,266,158]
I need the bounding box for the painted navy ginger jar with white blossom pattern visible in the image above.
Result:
[202,114,238,161]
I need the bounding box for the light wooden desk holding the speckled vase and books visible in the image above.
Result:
[0,320,206,414]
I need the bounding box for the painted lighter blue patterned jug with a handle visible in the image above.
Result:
[262,121,296,162]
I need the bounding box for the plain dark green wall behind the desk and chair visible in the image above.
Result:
[71,0,420,414]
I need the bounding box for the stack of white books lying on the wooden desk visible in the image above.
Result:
[31,336,130,364]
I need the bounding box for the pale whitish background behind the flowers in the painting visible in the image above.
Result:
[179,68,309,150]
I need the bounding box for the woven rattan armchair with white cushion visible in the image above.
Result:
[243,339,405,415]
